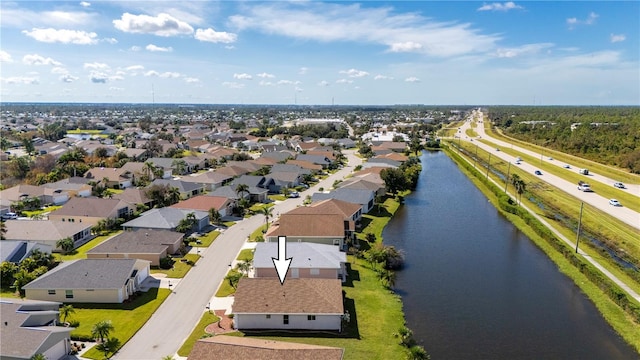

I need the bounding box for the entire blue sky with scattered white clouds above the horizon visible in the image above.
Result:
[0,0,640,105]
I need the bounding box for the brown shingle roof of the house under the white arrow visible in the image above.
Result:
[232,278,344,315]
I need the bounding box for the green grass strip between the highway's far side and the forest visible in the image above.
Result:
[485,125,640,184]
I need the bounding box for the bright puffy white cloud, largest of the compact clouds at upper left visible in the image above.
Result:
[113,13,193,37]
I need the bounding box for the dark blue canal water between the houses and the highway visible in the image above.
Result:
[383,152,640,360]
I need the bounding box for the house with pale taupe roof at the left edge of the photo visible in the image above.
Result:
[5,220,93,250]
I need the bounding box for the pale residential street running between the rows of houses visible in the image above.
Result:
[113,150,362,360]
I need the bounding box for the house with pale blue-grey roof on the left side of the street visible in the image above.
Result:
[122,207,209,231]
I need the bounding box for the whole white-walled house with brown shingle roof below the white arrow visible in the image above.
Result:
[232,278,344,331]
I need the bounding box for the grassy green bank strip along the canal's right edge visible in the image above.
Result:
[445,144,640,353]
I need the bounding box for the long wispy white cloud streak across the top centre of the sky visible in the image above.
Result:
[229,1,501,57]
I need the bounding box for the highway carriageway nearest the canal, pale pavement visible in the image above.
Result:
[461,115,640,229]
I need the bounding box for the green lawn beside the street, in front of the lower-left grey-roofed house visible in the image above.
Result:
[69,288,171,360]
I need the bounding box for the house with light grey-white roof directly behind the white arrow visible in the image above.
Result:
[252,242,347,282]
